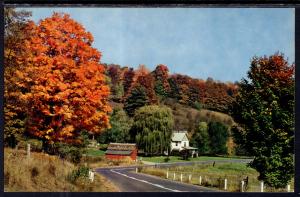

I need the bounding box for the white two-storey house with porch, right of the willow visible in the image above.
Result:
[171,131,198,156]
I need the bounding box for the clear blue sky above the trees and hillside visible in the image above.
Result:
[17,7,295,82]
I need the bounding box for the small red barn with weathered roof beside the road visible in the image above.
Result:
[105,143,137,160]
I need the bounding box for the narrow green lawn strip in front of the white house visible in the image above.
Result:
[139,156,248,163]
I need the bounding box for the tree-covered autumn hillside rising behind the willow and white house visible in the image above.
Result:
[97,64,238,154]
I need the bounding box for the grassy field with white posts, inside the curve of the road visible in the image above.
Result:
[141,163,294,192]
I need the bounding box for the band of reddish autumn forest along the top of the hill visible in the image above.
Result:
[106,64,238,116]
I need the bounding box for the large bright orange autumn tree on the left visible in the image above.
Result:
[16,13,111,143]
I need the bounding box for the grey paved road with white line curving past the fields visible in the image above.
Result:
[96,160,251,192]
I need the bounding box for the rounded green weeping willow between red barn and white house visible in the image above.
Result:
[130,105,174,155]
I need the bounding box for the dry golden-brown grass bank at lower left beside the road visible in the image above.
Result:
[4,148,118,192]
